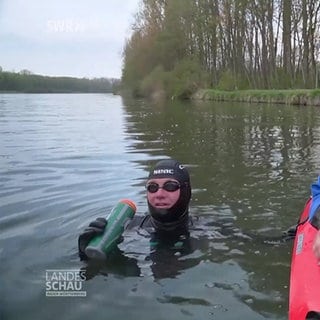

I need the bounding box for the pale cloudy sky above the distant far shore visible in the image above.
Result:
[0,0,140,78]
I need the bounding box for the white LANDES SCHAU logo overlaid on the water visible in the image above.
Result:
[46,269,87,297]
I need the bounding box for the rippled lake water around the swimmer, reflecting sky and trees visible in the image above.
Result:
[0,94,320,320]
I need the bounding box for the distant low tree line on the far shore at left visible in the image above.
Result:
[0,68,119,93]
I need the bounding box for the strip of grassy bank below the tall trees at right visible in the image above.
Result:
[191,89,320,106]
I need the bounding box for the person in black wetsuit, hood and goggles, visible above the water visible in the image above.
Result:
[78,159,192,259]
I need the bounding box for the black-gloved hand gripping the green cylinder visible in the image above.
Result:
[78,218,108,260]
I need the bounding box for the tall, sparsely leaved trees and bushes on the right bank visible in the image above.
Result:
[122,0,320,97]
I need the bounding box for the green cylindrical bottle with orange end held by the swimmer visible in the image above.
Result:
[85,199,137,260]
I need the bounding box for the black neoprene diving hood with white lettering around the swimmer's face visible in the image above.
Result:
[148,159,191,228]
